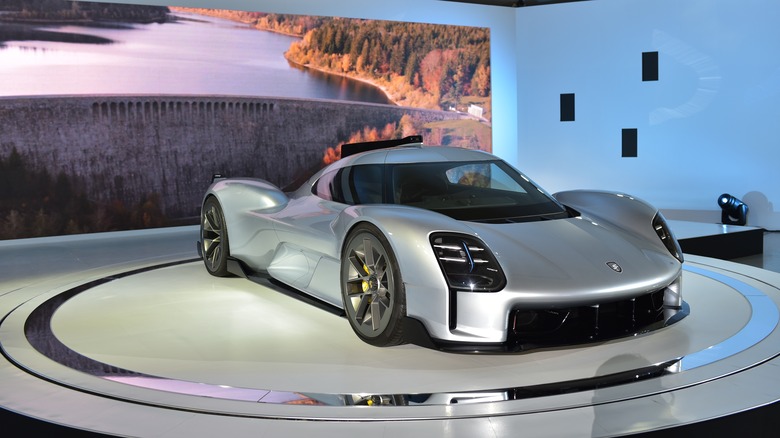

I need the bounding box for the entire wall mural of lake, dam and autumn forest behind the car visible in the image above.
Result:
[0,0,491,239]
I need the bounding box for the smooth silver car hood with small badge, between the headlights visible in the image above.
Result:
[469,217,680,304]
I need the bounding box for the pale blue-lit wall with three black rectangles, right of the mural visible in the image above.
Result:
[516,0,780,230]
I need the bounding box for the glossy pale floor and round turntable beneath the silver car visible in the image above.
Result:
[0,224,780,437]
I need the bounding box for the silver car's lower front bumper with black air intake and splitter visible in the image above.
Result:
[405,277,690,352]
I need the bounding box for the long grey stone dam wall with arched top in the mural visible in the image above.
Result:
[0,95,468,218]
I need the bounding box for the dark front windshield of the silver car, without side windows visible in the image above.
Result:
[394,160,569,222]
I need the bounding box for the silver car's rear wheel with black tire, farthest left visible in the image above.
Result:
[200,196,230,277]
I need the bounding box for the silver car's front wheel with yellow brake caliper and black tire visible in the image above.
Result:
[341,223,406,347]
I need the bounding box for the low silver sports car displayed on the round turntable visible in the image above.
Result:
[198,136,687,351]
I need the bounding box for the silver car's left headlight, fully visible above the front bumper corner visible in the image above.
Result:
[431,233,506,292]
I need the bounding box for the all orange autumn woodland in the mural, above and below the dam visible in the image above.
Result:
[174,8,491,162]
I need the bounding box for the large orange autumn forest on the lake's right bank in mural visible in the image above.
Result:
[286,18,490,110]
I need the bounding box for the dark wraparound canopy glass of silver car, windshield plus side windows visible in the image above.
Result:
[314,160,568,222]
